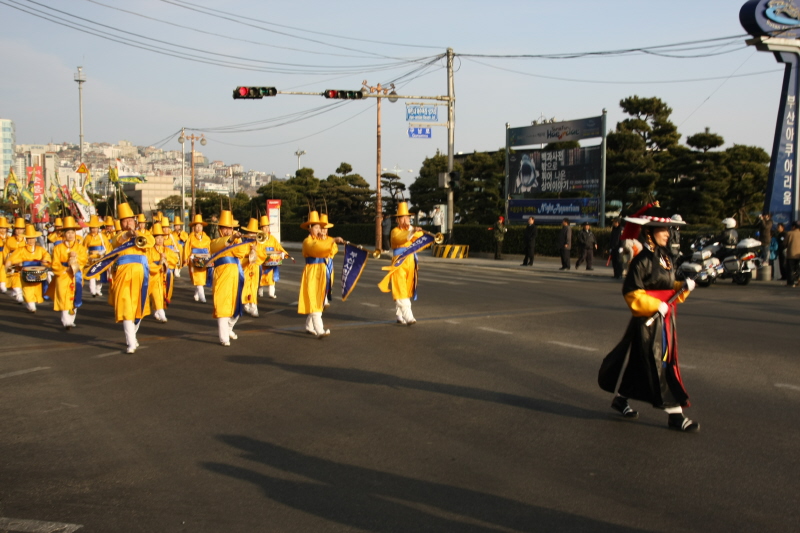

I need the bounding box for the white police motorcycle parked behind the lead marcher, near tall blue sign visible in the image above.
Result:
[680,218,761,287]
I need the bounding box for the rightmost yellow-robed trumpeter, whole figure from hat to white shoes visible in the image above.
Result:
[378,202,432,326]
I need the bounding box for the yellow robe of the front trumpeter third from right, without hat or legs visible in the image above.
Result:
[211,237,252,318]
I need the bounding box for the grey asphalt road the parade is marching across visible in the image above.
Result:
[0,257,800,533]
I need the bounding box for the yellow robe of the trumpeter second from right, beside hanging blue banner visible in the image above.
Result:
[297,235,339,315]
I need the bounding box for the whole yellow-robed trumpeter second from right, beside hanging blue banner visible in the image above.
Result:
[297,211,344,338]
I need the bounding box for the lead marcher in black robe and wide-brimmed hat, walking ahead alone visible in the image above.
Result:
[598,207,700,432]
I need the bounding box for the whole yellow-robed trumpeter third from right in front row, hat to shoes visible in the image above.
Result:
[211,211,256,346]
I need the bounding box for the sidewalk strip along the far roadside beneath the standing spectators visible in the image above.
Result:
[281,242,786,287]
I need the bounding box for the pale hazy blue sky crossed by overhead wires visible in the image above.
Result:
[0,0,783,184]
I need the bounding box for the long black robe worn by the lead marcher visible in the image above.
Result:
[598,248,689,408]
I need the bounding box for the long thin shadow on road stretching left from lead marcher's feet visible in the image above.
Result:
[225,355,607,420]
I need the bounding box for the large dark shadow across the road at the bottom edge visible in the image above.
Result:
[201,435,644,533]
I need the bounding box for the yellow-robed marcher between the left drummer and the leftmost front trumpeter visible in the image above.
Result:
[47,216,89,331]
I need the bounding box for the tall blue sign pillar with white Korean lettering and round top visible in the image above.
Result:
[739,0,800,224]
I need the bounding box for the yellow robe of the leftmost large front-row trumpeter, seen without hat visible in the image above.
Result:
[108,232,153,322]
